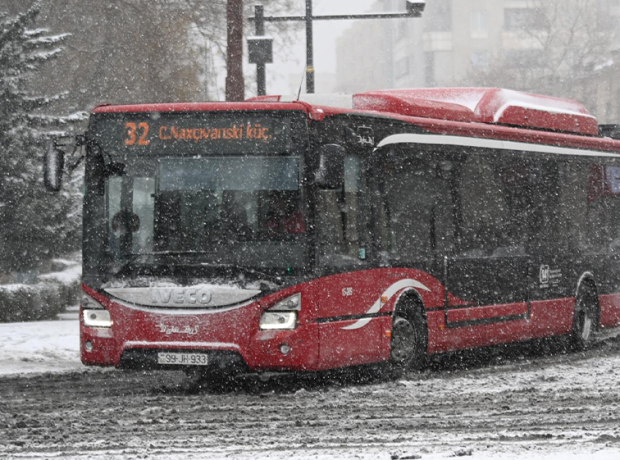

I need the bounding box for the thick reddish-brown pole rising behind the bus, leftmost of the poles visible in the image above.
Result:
[226,0,245,101]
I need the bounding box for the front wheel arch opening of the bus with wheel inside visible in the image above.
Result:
[390,289,428,371]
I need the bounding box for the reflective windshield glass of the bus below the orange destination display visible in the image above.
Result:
[105,156,306,271]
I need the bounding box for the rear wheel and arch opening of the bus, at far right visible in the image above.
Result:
[570,272,601,351]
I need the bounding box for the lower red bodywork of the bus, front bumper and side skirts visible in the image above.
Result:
[81,268,620,371]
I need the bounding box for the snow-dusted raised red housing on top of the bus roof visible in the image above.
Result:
[250,88,599,136]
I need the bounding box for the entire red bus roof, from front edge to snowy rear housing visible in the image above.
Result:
[93,88,600,137]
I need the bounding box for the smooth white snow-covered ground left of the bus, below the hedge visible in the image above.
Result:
[0,319,84,375]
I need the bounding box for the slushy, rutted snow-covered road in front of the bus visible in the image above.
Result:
[0,324,620,460]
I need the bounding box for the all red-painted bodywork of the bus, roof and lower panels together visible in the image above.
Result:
[80,89,620,371]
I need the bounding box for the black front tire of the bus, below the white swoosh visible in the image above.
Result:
[390,307,427,375]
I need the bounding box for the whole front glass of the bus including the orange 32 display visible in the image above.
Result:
[85,114,308,274]
